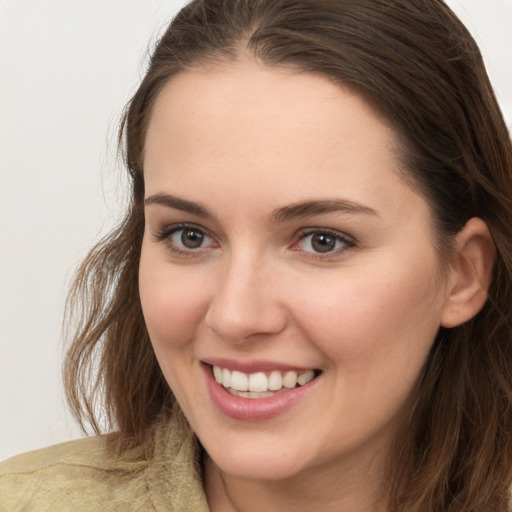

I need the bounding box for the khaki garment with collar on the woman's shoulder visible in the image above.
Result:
[0,414,208,512]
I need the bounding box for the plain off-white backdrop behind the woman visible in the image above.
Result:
[0,0,512,460]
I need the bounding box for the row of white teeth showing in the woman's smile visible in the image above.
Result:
[213,366,315,392]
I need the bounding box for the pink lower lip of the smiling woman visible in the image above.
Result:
[202,364,318,422]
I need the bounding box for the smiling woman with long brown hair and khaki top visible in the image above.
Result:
[0,0,512,512]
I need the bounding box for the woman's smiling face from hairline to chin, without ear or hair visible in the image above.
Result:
[140,62,447,480]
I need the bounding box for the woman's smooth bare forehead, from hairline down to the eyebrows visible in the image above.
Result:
[144,62,424,224]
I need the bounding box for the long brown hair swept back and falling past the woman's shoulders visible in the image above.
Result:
[64,0,512,512]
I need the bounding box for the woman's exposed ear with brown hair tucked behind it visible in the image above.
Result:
[441,217,496,327]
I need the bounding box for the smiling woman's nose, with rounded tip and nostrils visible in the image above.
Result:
[205,256,287,343]
